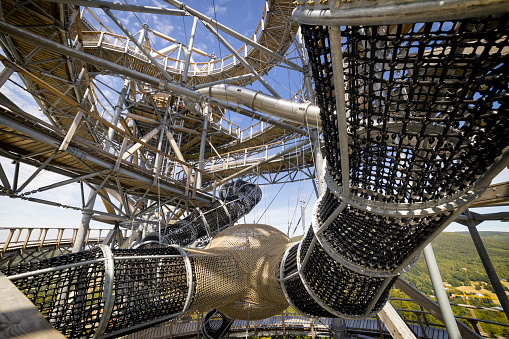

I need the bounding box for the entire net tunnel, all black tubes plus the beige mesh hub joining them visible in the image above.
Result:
[2,1,509,338]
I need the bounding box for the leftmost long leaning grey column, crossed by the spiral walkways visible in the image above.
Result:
[72,25,148,253]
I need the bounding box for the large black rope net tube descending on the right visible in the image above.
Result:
[287,14,509,317]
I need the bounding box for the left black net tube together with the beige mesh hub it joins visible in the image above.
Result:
[3,225,290,338]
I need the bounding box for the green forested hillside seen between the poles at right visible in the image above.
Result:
[402,232,509,294]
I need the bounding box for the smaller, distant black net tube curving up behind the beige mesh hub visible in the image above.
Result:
[138,180,262,247]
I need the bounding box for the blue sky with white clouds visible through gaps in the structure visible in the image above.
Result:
[0,0,509,242]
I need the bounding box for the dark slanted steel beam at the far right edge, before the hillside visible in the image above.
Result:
[465,210,509,319]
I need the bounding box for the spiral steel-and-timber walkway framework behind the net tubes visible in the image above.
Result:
[0,0,509,339]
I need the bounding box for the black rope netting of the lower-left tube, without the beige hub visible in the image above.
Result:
[2,247,189,338]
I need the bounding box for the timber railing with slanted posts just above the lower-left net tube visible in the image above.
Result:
[0,227,117,258]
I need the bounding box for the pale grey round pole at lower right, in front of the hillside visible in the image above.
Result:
[422,244,461,339]
